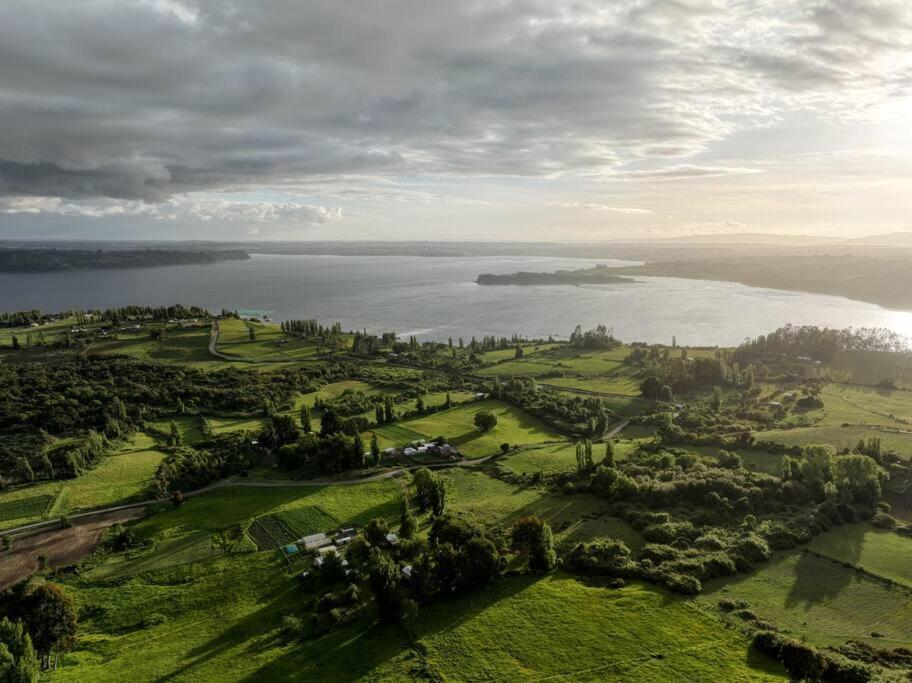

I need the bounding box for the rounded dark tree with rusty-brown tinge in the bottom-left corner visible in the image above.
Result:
[21,583,77,669]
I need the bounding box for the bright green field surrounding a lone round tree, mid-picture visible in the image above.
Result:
[397,400,562,457]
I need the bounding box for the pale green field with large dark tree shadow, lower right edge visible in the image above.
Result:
[696,544,912,648]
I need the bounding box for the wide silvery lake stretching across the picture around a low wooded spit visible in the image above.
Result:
[0,255,912,346]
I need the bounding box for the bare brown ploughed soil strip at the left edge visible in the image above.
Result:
[0,508,145,589]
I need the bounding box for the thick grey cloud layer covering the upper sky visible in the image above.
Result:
[0,0,908,202]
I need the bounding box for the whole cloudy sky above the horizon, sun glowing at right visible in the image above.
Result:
[0,0,912,241]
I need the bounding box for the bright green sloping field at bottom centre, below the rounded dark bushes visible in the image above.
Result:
[418,573,785,682]
